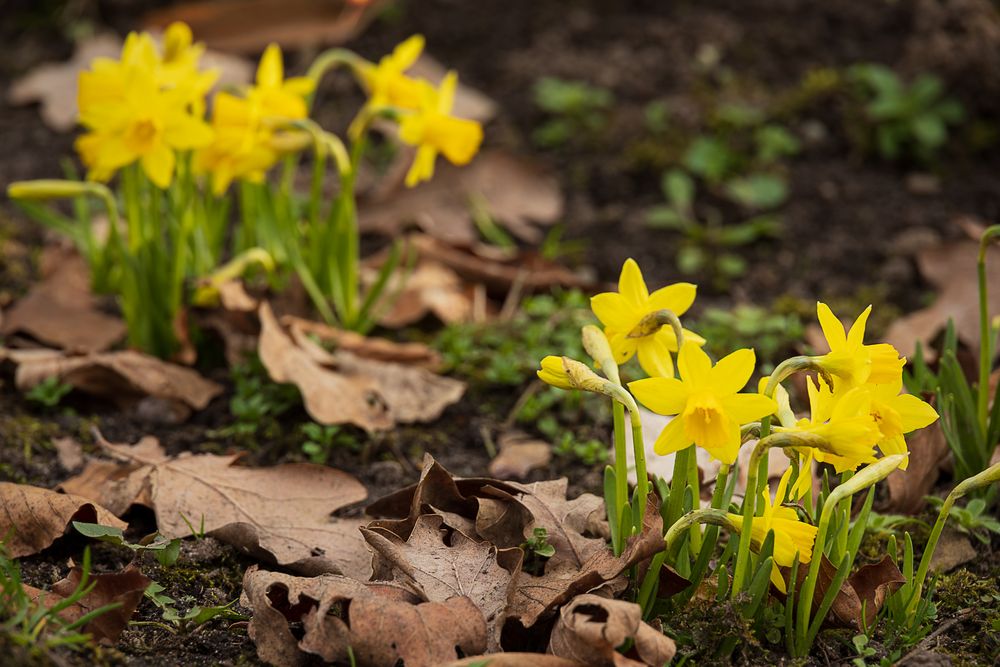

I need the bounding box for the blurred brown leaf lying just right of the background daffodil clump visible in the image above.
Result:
[359,150,563,245]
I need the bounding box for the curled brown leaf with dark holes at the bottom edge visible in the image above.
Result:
[241,566,486,667]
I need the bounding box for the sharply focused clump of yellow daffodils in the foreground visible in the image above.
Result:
[538,259,938,654]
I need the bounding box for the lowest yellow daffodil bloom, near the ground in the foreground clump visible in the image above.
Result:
[726,468,817,593]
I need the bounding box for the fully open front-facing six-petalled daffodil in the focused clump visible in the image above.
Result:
[629,341,777,464]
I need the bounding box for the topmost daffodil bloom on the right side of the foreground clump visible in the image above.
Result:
[816,302,906,389]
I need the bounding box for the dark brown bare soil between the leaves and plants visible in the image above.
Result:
[0,0,1000,665]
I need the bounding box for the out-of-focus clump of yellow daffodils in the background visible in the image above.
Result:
[8,23,483,357]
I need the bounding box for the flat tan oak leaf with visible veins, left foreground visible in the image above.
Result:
[64,440,371,578]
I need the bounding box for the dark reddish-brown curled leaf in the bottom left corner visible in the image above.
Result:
[23,563,152,644]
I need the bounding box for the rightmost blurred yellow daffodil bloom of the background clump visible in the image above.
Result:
[399,72,483,187]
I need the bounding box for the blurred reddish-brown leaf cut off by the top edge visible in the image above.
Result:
[143,0,384,54]
